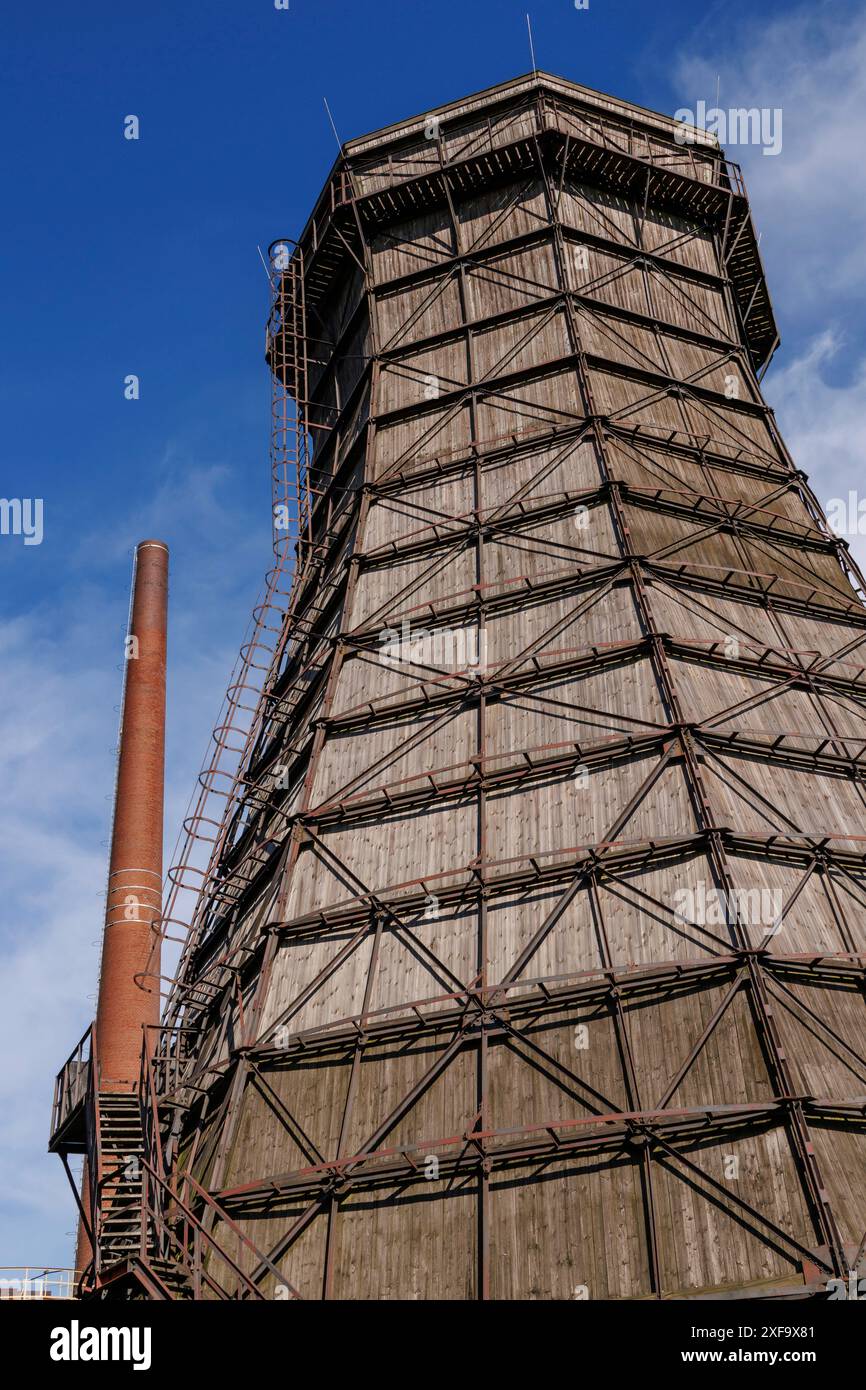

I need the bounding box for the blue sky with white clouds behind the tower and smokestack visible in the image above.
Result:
[0,0,866,1265]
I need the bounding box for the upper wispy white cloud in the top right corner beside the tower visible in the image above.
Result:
[676,4,866,318]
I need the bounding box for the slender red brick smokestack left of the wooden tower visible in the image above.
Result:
[76,541,168,1269]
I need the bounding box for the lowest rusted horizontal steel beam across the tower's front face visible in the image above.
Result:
[215,1095,796,1206]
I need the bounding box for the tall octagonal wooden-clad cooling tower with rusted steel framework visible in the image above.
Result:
[55,74,866,1300]
